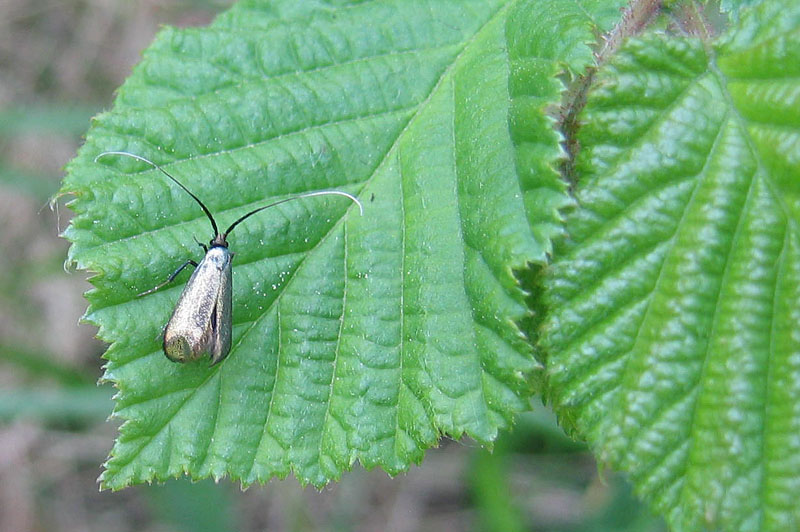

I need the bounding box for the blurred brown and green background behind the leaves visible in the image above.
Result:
[0,0,664,532]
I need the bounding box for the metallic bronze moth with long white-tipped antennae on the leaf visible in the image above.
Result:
[95,151,363,366]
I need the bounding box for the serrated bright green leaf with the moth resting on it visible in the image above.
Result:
[57,0,593,489]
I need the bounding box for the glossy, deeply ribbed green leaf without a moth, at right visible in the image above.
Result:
[541,0,800,530]
